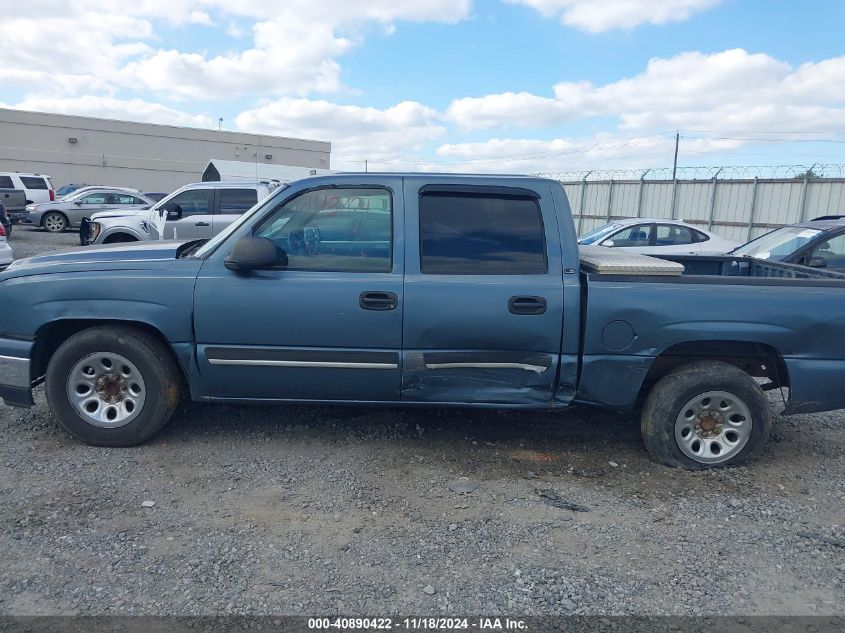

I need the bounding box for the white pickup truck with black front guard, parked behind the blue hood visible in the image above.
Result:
[79,182,278,245]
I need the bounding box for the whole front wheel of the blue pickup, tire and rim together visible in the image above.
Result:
[45,326,181,446]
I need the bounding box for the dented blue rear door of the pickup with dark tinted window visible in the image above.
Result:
[402,179,563,406]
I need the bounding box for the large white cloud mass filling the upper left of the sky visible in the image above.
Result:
[0,0,471,99]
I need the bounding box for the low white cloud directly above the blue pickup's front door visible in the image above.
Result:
[235,98,446,170]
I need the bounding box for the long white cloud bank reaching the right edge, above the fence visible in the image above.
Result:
[446,49,845,133]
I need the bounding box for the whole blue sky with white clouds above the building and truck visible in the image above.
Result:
[0,0,845,172]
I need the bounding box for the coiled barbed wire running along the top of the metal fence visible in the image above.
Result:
[537,163,845,182]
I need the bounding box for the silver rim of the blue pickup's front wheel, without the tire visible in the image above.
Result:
[67,352,147,429]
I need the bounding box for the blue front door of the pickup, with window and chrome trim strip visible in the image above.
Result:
[195,176,404,401]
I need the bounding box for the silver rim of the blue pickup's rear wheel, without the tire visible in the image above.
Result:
[675,391,753,464]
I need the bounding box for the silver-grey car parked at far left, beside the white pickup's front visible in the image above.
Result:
[21,187,153,233]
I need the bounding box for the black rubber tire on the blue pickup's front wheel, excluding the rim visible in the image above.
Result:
[45,326,182,446]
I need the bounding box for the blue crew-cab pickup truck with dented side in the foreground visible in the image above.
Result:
[0,173,845,469]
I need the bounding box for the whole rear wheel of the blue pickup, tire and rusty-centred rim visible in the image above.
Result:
[641,361,772,470]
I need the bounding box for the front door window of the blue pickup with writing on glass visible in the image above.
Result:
[254,188,393,272]
